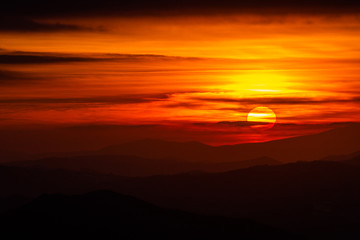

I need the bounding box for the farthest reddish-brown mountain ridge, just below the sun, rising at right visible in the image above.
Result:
[87,124,360,163]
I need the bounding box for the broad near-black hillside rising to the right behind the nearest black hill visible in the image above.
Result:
[0,157,360,239]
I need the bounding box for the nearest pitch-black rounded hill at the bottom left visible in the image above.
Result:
[0,191,300,240]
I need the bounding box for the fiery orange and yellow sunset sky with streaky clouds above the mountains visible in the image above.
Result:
[0,0,360,145]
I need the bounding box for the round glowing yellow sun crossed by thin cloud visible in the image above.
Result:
[247,107,276,130]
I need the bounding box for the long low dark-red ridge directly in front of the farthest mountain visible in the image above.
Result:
[6,155,280,176]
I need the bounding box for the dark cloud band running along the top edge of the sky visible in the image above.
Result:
[0,0,360,17]
